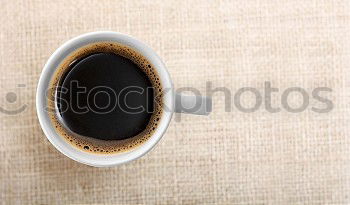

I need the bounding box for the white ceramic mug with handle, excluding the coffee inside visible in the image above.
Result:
[36,31,212,167]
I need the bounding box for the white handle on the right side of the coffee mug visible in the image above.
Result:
[175,93,212,115]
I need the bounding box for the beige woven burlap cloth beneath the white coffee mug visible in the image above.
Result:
[0,0,350,204]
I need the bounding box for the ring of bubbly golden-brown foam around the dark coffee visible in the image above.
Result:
[47,42,163,154]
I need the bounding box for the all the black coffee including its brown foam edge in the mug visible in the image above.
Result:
[48,42,161,153]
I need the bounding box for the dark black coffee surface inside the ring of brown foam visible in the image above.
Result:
[57,53,154,140]
